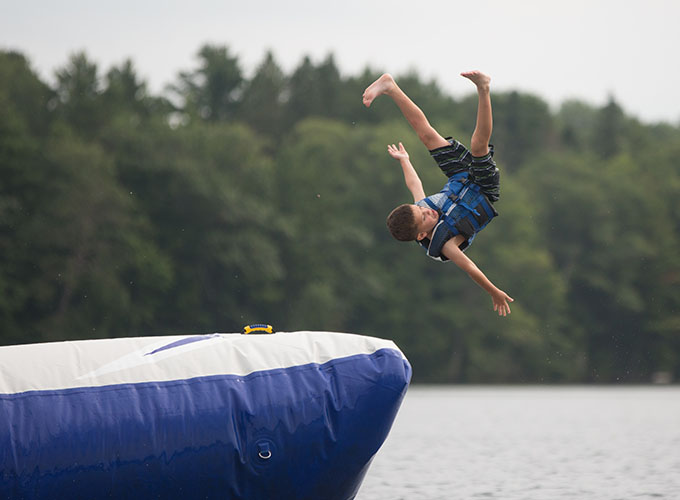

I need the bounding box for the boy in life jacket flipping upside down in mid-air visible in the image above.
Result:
[363,71,514,316]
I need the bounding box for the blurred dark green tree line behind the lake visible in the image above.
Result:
[0,45,680,383]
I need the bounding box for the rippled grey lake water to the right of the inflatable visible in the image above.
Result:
[356,386,680,500]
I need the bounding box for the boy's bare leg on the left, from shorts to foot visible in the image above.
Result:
[363,73,449,150]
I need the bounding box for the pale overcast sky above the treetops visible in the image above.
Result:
[0,0,680,124]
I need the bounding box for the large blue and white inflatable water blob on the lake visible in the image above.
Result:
[0,332,411,500]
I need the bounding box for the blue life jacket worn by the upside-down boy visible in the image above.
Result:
[418,178,498,261]
